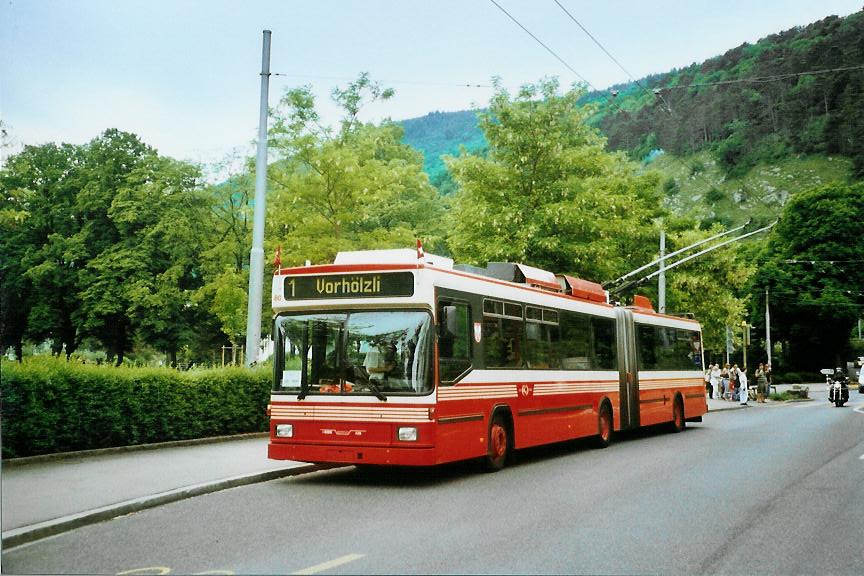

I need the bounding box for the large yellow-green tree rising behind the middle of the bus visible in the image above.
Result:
[447,80,663,280]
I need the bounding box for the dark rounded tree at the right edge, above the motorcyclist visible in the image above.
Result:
[752,183,864,370]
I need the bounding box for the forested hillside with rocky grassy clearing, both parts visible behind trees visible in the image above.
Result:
[403,12,864,216]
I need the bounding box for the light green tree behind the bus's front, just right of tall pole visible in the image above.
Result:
[266,74,443,264]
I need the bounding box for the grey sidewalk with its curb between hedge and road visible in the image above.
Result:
[0,436,319,548]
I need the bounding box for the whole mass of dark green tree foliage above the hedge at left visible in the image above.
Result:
[0,129,213,363]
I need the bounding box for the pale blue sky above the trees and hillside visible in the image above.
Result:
[0,0,862,171]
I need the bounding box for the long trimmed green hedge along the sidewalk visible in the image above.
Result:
[0,358,271,458]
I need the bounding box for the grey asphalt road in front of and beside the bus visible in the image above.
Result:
[2,391,864,574]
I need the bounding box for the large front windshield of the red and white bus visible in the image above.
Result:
[273,310,433,400]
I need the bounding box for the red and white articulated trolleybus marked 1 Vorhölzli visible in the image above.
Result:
[268,249,707,470]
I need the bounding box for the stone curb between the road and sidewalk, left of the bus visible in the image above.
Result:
[2,464,340,550]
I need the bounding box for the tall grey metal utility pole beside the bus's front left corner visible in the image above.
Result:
[246,30,270,366]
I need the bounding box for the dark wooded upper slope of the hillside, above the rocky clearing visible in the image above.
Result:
[593,12,864,177]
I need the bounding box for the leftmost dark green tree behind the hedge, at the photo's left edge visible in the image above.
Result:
[0,144,82,359]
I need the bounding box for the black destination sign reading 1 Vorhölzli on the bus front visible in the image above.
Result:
[285,272,414,300]
